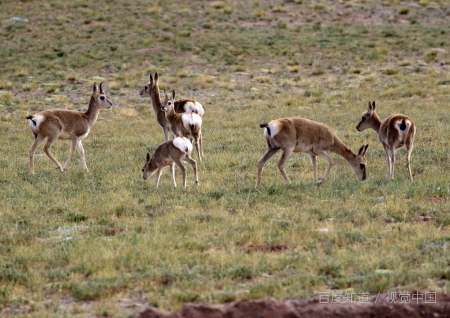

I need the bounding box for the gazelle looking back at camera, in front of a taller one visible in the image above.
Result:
[161,91,203,162]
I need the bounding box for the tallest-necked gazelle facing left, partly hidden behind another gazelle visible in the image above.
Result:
[139,73,204,141]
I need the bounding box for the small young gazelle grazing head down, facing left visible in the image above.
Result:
[142,137,198,189]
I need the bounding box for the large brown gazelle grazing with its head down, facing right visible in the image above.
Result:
[256,117,369,187]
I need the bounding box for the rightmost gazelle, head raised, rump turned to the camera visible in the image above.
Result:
[356,102,416,181]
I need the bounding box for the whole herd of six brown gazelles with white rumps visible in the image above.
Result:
[27,73,416,188]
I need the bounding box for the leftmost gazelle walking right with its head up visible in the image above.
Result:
[27,82,112,174]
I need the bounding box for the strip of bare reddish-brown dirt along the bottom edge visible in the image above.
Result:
[138,291,450,318]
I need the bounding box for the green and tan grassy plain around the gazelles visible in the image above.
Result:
[0,0,450,317]
